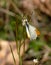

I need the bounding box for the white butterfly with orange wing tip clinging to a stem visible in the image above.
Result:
[23,19,40,40]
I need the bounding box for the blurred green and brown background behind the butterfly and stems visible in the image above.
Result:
[0,0,51,65]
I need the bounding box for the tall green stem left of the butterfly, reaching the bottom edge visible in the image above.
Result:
[15,17,22,65]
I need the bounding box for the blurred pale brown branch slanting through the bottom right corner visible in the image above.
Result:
[39,45,51,65]
